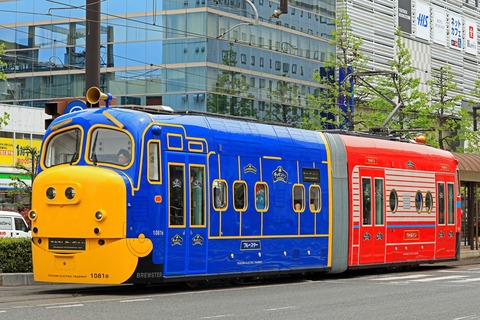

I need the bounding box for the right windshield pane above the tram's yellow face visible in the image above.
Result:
[88,128,132,167]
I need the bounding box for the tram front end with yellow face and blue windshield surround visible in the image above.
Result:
[29,109,152,284]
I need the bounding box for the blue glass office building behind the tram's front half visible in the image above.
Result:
[0,0,335,120]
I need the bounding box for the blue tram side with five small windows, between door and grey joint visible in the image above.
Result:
[202,121,329,274]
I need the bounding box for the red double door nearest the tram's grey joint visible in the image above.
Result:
[359,168,385,264]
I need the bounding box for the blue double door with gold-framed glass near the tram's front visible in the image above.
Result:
[165,153,207,276]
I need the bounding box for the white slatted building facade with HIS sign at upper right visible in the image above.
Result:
[346,0,480,110]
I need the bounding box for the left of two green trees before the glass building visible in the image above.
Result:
[207,43,257,117]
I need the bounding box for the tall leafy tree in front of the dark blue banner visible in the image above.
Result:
[302,3,367,130]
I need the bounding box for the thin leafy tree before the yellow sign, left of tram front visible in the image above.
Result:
[7,146,38,210]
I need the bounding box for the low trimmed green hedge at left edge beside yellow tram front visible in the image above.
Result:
[0,238,32,273]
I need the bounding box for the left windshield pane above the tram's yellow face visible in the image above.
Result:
[44,128,82,168]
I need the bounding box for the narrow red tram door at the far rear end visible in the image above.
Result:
[435,175,456,259]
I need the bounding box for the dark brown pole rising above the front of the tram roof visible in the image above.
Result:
[85,0,101,108]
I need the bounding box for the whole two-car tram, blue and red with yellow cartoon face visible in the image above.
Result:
[29,89,459,284]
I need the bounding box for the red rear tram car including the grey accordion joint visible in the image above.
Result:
[325,133,461,272]
